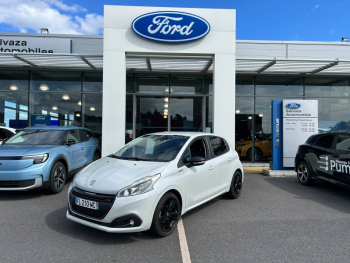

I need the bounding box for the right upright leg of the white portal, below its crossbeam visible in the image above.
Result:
[213,54,236,147]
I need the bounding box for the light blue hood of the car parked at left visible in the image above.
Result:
[0,143,59,156]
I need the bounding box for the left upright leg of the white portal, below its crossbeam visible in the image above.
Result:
[102,50,126,156]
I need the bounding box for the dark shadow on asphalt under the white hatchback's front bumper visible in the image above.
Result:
[45,207,158,245]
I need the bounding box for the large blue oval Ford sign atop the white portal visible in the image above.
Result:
[131,11,210,43]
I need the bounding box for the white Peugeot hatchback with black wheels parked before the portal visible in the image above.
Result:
[67,132,244,236]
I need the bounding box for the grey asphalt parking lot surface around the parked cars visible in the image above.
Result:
[0,174,350,262]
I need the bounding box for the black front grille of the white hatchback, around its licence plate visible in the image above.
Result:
[69,187,116,222]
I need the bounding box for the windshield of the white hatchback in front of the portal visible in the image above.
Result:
[110,134,189,162]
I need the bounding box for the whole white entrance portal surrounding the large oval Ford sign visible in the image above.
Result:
[102,6,236,156]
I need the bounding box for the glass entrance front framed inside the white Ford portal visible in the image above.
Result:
[125,74,213,142]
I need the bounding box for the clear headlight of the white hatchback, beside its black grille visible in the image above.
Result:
[117,174,160,197]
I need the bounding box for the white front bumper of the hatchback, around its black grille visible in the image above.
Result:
[66,185,159,233]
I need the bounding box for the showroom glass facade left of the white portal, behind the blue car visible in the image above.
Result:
[0,70,102,135]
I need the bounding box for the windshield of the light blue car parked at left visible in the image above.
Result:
[5,129,66,145]
